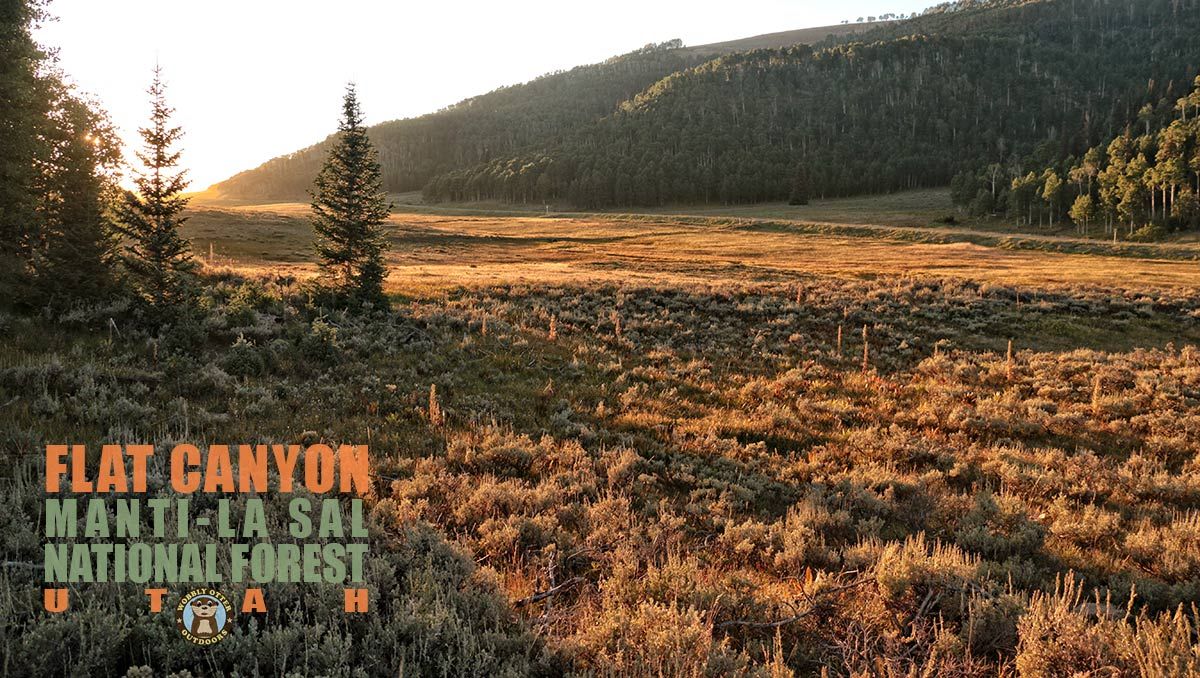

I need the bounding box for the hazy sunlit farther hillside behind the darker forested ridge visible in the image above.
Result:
[199,22,878,200]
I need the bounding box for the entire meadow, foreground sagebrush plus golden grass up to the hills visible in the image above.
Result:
[0,194,1200,677]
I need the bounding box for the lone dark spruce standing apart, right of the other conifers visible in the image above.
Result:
[312,84,391,302]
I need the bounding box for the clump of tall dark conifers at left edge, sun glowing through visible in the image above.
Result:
[0,0,120,304]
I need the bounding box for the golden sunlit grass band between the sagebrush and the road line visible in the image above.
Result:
[185,203,1200,294]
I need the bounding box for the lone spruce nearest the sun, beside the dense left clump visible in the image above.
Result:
[116,66,196,312]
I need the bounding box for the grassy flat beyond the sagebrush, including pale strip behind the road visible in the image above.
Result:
[184,191,1200,294]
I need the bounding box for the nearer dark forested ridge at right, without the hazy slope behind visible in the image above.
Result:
[426,0,1200,208]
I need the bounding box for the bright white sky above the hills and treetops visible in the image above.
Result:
[36,0,936,191]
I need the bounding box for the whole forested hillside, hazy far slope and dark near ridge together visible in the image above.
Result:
[214,0,1200,208]
